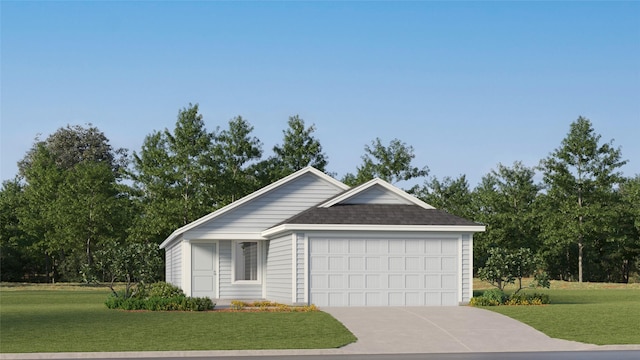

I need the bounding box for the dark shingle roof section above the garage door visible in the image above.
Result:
[278,204,479,226]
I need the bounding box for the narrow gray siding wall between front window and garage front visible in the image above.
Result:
[266,234,293,304]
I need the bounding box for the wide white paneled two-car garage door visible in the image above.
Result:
[309,238,459,306]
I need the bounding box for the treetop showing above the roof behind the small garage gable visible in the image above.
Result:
[342,138,429,186]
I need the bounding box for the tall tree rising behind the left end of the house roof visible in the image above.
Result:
[130,104,219,243]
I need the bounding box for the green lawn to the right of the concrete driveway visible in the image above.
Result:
[470,281,640,345]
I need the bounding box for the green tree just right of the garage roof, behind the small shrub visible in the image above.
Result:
[472,162,540,267]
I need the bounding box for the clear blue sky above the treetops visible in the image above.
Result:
[0,0,640,187]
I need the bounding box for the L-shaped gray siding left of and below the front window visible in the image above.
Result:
[218,240,262,300]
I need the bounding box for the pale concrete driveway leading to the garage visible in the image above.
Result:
[322,306,599,354]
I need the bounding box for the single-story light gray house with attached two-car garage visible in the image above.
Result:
[160,167,485,306]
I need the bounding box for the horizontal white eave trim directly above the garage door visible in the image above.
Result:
[261,224,485,238]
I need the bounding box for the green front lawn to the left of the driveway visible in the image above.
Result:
[0,285,356,353]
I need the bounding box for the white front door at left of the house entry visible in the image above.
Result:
[191,243,217,298]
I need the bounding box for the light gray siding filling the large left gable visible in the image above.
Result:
[185,174,341,239]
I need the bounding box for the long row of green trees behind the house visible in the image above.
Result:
[0,104,640,282]
